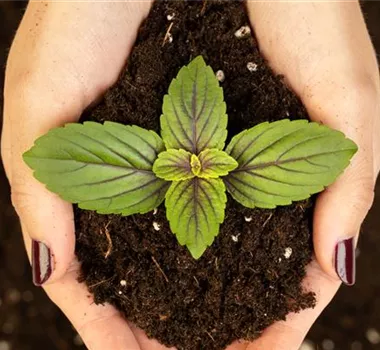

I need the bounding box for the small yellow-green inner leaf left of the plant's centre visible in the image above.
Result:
[153,149,195,181]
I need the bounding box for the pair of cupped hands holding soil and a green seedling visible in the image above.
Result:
[1,0,380,350]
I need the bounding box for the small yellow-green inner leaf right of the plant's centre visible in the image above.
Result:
[198,149,239,178]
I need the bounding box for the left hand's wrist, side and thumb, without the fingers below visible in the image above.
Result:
[3,2,150,285]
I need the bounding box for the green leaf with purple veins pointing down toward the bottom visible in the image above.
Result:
[165,177,227,259]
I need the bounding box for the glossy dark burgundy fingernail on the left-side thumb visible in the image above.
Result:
[32,240,52,287]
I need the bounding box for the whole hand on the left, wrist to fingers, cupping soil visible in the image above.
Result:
[1,1,172,350]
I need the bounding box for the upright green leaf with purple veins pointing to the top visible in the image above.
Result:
[161,56,227,155]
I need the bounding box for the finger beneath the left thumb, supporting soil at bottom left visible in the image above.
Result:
[22,225,142,350]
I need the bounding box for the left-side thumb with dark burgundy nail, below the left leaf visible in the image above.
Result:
[11,182,75,286]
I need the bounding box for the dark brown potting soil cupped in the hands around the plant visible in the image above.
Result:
[76,0,315,350]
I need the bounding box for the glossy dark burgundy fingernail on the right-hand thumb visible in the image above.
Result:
[335,238,356,286]
